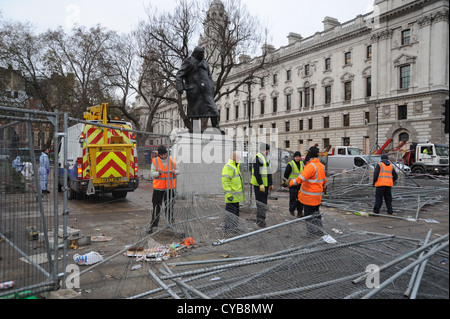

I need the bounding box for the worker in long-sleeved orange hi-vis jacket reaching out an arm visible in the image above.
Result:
[289,149,327,236]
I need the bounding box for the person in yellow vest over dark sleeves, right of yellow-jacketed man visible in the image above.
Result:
[250,144,273,228]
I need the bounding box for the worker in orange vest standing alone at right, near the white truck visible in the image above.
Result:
[373,154,398,215]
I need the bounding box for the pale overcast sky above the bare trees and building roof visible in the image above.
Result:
[0,0,374,48]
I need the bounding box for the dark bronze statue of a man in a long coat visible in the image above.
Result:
[176,47,220,131]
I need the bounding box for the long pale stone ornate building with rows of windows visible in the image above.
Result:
[147,0,449,153]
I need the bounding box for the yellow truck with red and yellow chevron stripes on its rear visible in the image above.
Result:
[58,103,139,199]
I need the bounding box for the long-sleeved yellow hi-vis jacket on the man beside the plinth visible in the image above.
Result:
[222,159,245,203]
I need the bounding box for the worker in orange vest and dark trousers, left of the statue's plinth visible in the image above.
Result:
[148,145,180,233]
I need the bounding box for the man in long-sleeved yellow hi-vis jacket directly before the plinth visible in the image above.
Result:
[222,152,245,231]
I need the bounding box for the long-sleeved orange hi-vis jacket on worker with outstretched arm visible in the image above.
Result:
[289,158,327,206]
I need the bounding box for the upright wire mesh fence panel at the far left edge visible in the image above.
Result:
[0,107,64,299]
